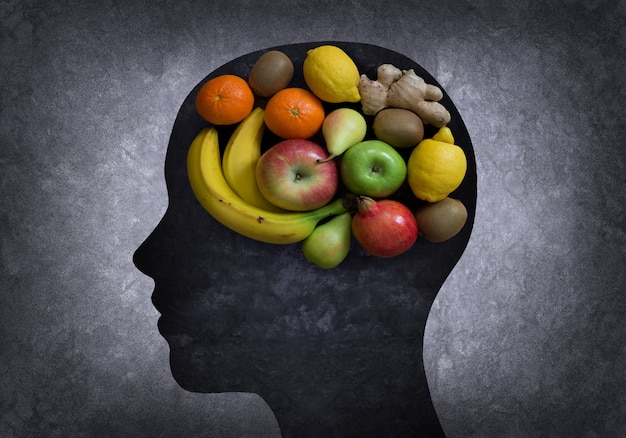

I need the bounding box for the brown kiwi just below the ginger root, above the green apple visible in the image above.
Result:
[372,108,424,149]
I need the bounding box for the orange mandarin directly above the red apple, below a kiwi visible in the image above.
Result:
[264,87,325,139]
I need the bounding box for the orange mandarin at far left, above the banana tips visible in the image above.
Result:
[196,75,254,125]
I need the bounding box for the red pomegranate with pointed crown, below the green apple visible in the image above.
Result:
[352,196,417,257]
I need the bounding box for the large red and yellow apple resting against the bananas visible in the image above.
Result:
[256,139,339,211]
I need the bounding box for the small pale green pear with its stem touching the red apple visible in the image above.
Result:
[322,108,367,161]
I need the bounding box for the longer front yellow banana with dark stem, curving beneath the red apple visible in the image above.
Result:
[187,127,350,244]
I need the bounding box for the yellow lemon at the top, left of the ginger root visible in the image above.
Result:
[302,45,361,103]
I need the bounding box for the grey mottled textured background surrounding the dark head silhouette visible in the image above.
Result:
[0,0,626,437]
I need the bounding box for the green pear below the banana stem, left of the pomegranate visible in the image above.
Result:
[302,212,352,269]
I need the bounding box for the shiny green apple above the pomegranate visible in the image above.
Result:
[340,140,407,198]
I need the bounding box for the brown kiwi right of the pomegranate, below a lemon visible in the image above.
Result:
[415,197,467,243]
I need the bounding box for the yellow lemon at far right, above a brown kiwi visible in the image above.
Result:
[407,128,467,202]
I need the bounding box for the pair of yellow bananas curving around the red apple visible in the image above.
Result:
[187,108,350,244]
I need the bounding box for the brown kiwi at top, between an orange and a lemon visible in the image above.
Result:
[248,50,293,97]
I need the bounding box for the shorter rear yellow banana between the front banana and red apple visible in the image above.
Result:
[222,107,284,211]
